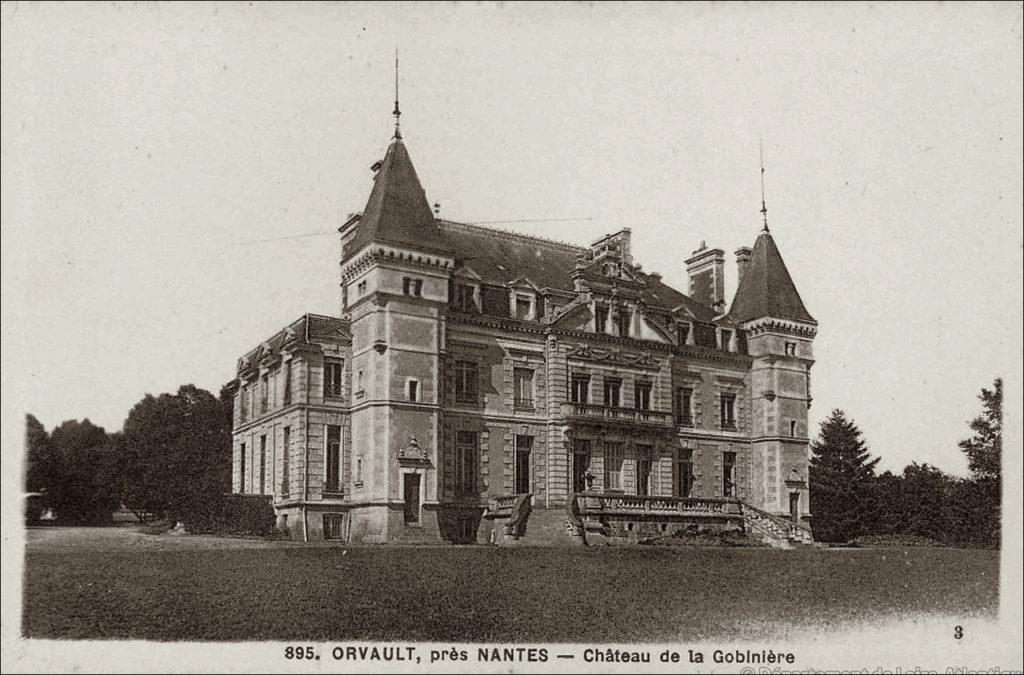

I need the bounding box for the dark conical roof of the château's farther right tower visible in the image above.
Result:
[729,231,817,324]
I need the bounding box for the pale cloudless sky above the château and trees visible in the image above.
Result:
[0,3,1024,474]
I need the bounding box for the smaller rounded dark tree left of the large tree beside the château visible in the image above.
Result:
[44,419,120,524]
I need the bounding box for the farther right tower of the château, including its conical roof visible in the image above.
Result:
[729,229,817,522]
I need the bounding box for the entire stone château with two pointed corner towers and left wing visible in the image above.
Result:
[224,120,817,546]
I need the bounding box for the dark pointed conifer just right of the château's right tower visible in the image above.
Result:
[810,409,879,542]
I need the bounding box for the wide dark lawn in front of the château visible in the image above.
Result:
[23,529,998,642]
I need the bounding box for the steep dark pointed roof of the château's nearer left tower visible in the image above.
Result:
[343,136,451,259]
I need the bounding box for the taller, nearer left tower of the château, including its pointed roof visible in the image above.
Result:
[341,123,455,542]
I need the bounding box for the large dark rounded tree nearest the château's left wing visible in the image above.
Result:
[119,384,231,521]
